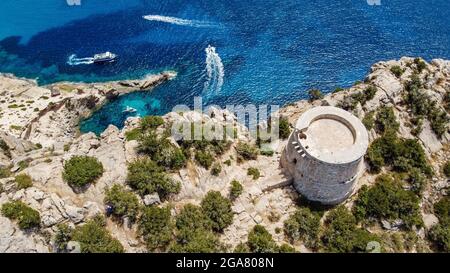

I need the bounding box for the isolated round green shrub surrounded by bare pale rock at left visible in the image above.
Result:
[63,156,103,187]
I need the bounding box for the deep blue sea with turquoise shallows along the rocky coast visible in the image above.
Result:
[0,0,450,133]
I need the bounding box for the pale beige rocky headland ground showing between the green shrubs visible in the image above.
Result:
[0,57,450,252]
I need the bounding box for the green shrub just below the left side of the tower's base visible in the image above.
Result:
[284,208,321,248]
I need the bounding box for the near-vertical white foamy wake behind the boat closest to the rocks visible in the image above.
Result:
[203,45,225,95]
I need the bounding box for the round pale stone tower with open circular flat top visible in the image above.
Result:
[282,106,369,205]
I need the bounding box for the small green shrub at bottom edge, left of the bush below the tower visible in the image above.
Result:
[247,225,278,253]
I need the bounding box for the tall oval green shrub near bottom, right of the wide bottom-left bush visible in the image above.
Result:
[139,206,173,251]
